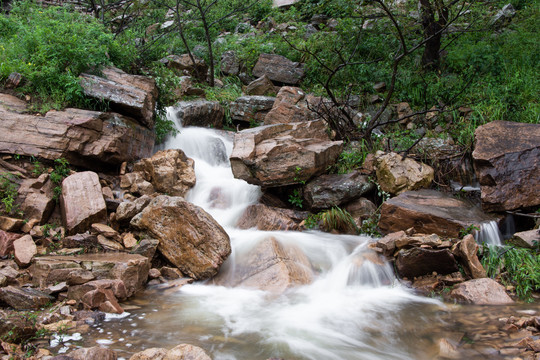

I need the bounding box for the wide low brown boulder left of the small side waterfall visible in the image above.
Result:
[379,189,494,238]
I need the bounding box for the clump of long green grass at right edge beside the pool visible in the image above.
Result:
[481,244,540,302]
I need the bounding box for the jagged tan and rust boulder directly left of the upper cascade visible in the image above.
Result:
[133,149,196,196]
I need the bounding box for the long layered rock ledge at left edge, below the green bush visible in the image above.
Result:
[0,94,155,170]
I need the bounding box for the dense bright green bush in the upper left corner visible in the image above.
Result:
[0,0,132,111]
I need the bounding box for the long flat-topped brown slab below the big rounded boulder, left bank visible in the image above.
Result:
[31,253,150,297]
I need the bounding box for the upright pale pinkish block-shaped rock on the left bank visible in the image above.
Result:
[60,171,107,235]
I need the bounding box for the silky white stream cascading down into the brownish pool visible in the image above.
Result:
[73,112,536,360]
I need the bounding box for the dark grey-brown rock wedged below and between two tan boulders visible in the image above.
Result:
[304,171,375,209]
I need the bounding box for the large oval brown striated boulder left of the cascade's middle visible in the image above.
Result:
[131,195,231,279]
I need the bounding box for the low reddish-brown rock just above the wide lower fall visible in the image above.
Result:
[236,204,309,231]
